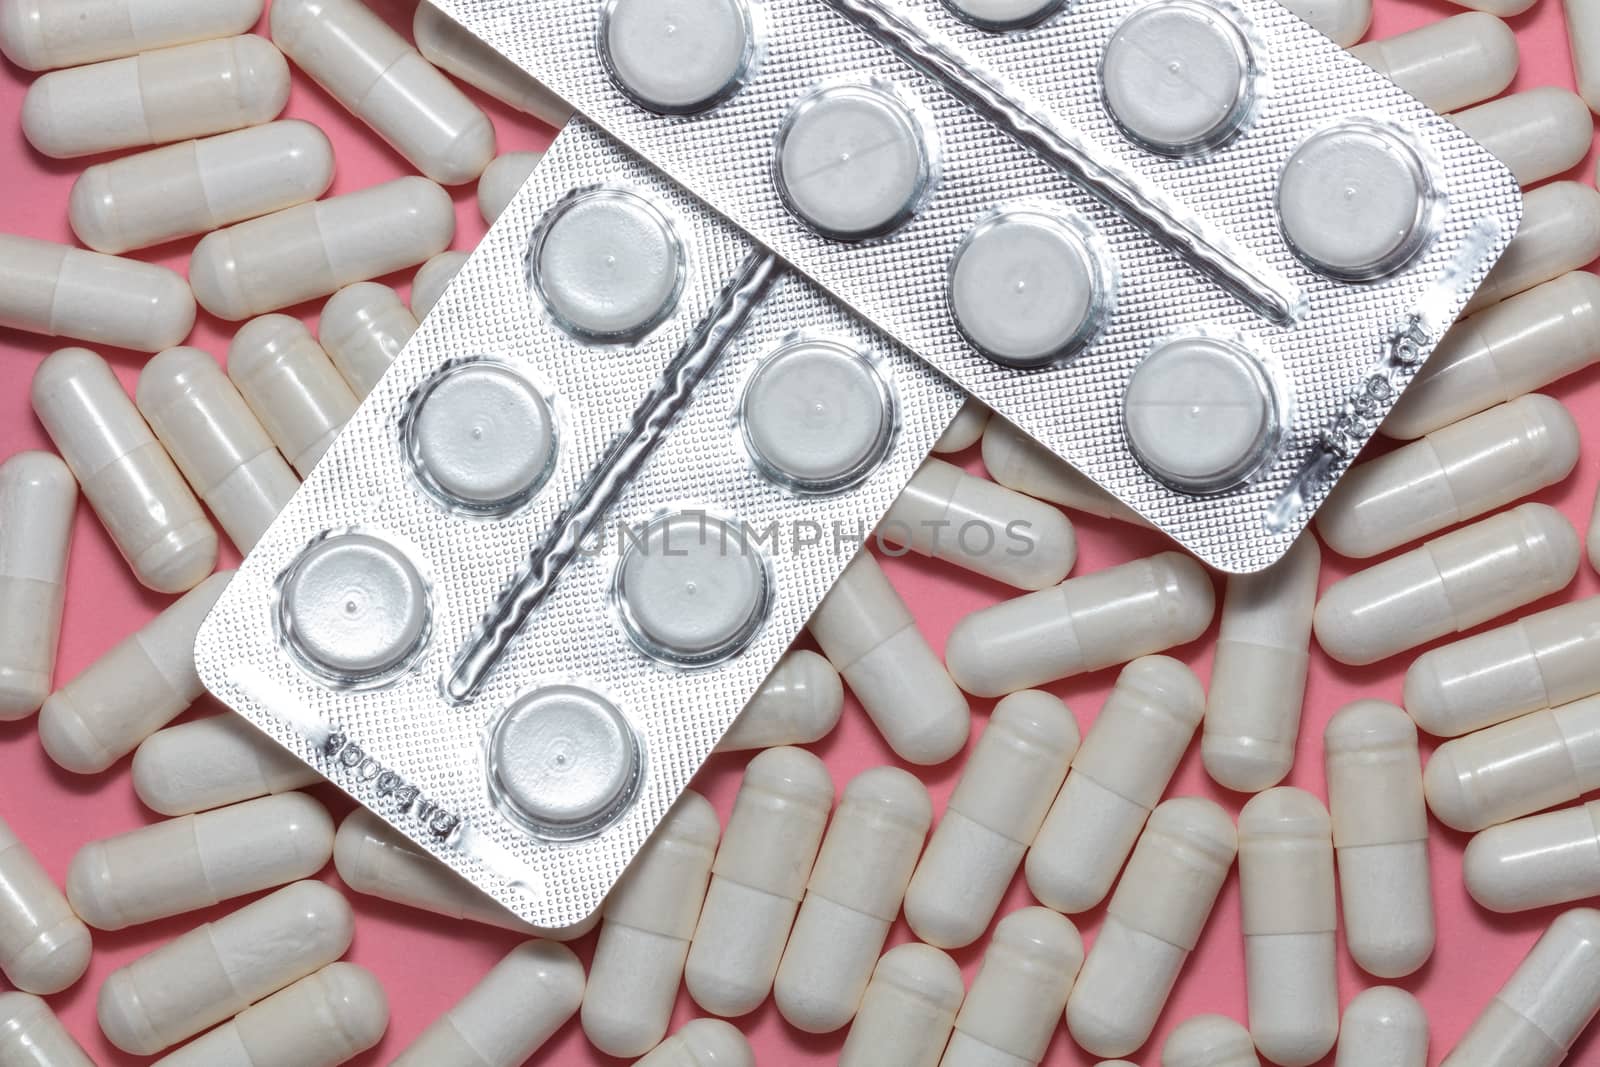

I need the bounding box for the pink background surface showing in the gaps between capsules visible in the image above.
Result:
[0,0,1600,1067]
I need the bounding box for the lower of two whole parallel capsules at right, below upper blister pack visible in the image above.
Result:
[1314,504,1578,664]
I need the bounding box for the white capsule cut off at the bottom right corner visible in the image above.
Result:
[1438,907,1600,1067]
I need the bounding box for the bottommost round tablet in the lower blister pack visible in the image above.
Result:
[488,685,643,838]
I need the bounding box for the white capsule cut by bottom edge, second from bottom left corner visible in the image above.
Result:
[152,963,389,1067]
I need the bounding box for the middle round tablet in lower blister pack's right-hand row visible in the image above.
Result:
[616,512,768,665]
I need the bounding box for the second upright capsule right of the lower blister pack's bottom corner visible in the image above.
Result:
[683,749,834,1017]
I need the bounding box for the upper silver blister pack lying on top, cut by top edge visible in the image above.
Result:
[437,0,1520,573]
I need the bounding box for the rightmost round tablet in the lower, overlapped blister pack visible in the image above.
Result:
[739,341,894,493]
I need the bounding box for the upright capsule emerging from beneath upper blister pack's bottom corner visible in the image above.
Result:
[1200,533,1322,793]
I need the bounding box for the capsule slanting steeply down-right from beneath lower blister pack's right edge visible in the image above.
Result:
[808,552,971,766]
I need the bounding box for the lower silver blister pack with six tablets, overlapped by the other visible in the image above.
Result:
[195,122,962,928]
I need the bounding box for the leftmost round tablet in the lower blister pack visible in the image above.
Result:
[278,533,429,681]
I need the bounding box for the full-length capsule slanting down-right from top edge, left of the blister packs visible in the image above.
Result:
[267,0,494,186]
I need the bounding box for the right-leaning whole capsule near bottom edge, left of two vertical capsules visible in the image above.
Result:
[1067,797,1238,1056]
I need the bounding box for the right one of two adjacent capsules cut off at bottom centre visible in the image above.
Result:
[939,907,1083,1067]
